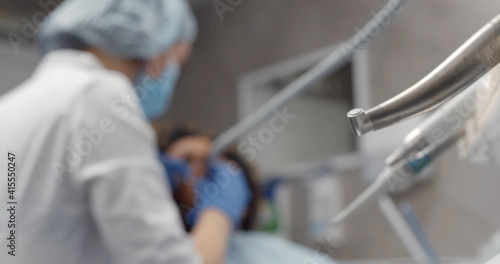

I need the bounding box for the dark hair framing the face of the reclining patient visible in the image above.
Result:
[154,123,260,230]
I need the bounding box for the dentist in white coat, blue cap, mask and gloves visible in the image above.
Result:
[0,0,251,264]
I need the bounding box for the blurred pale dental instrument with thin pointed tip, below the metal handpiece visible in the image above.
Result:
[330,85,482,226]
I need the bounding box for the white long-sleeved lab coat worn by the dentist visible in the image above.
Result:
[0,50,201,264]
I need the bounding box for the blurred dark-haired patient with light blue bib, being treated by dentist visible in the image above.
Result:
[155,124,335,264]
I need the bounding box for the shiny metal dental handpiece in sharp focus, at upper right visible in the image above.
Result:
[347,12,500,136]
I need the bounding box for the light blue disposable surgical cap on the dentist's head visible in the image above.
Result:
[38,0,197,60]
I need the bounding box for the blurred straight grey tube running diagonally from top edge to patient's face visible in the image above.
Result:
[210,0,410,159]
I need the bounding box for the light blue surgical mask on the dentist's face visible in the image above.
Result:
[134,60,181,120]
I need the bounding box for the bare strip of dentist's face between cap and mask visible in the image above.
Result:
[146,42,193,78]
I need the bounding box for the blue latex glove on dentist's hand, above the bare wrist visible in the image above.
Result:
[187,161,252,228]
